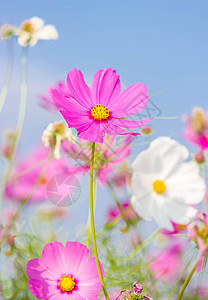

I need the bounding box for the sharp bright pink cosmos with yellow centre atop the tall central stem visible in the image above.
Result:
[53,68,152,143]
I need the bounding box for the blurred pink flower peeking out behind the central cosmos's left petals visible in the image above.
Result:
[39,82,69,112]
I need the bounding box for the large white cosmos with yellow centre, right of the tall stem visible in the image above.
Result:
[131,137,206,230]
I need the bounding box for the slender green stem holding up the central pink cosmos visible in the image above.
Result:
[90,143,110,300]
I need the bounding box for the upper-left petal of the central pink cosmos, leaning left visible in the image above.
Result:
[67,69,93,108]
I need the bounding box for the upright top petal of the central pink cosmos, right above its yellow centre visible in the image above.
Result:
[92,68,121,106]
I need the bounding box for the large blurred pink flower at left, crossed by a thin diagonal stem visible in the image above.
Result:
[6,147,69,202]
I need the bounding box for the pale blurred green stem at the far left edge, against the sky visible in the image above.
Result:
[0,39,14,113]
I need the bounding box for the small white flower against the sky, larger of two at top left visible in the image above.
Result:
[15,17,58,47]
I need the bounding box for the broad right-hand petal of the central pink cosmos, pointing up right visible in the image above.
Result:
[109,82,149,118]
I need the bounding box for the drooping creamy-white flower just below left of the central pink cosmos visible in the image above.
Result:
[42,122,75,159]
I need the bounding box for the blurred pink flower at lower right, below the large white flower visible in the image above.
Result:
[150,243,183,282]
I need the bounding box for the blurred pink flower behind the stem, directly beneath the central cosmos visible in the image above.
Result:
[62,135,132,187]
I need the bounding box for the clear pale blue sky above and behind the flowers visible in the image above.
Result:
[0,0,208,234]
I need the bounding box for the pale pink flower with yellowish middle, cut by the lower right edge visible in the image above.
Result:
[188,212,208,272]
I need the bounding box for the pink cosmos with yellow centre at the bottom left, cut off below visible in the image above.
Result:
[27,242,104,300]
